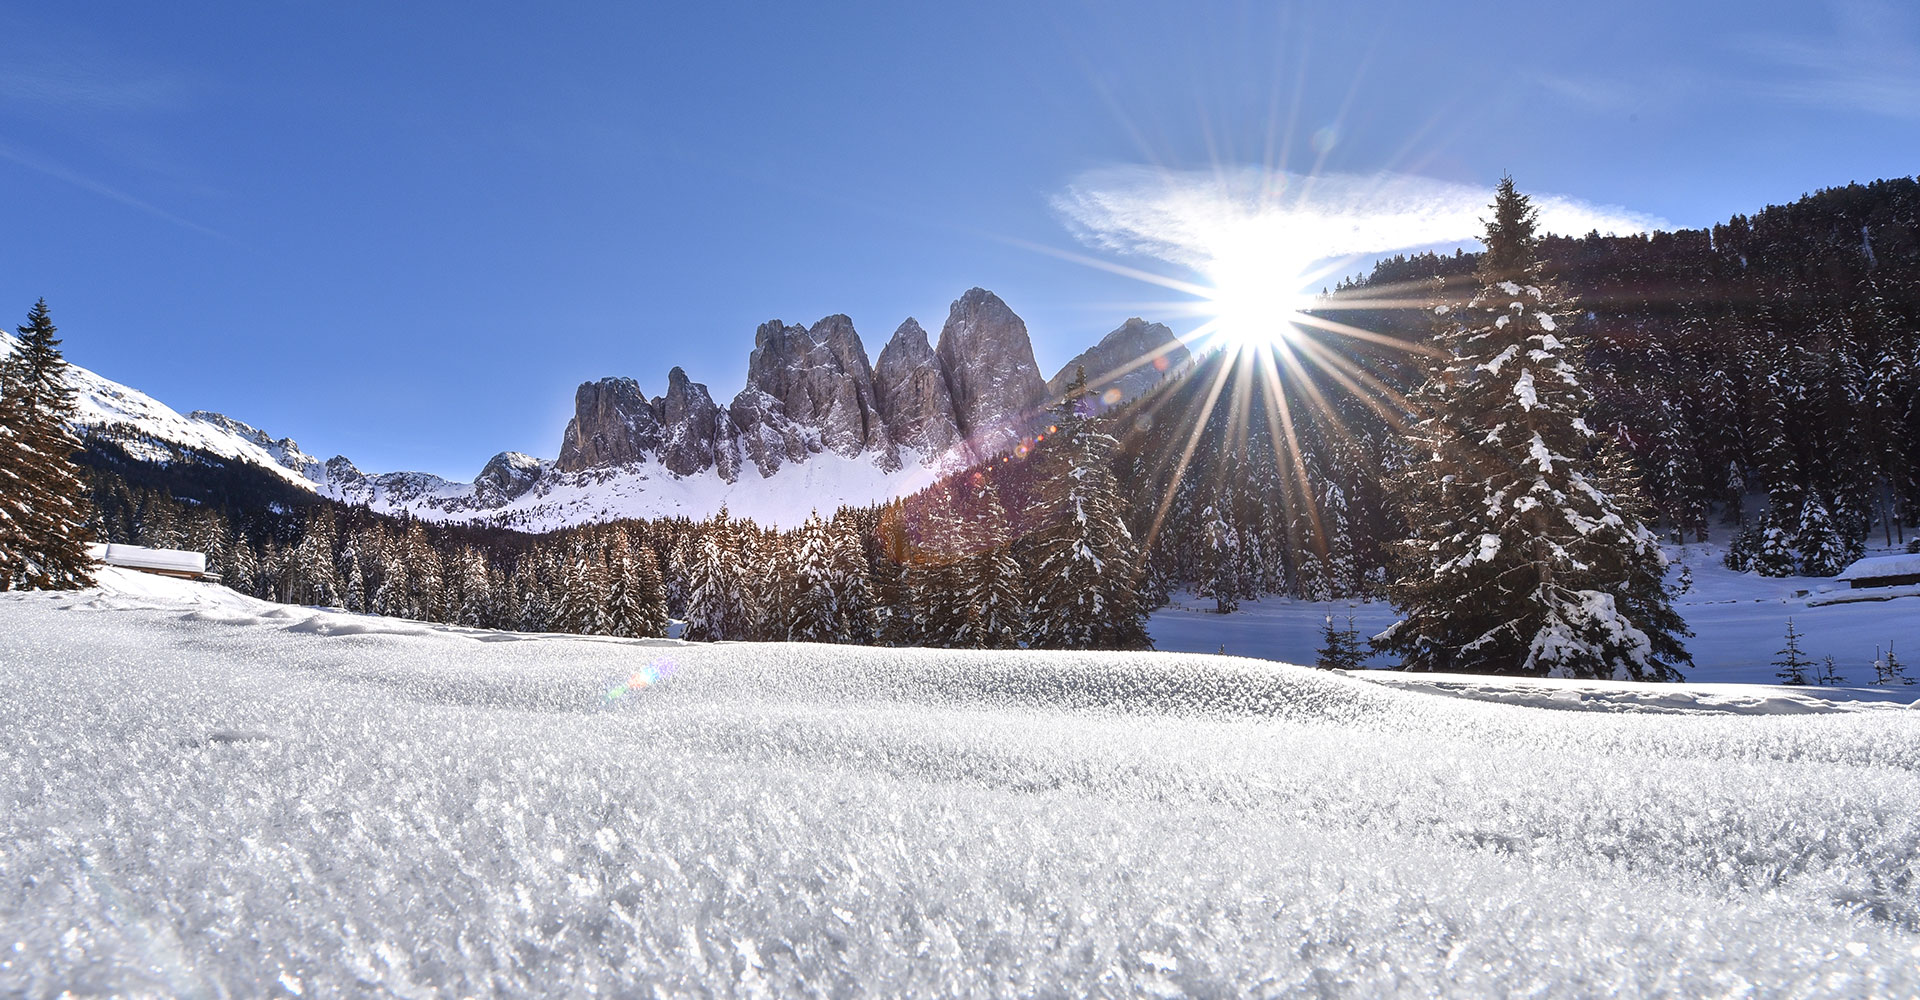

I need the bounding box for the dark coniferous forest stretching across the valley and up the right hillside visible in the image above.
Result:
[11,179,1920,679]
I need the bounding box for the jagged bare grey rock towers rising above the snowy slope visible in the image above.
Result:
[549,288,1082,485]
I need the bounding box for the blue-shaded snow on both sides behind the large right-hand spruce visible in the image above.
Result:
[1148,543,1920,687]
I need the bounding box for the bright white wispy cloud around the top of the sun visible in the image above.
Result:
[1054,167,1670,271]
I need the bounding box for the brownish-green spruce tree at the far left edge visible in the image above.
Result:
[0,299,94,591]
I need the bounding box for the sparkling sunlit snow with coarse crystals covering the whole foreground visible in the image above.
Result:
[0,570,1920,996]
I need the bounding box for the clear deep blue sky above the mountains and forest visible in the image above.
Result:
[0,0,1920,478]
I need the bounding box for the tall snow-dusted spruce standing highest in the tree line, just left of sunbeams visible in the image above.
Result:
[1029,370,1154,649]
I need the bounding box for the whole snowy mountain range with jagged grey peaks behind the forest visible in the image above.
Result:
[26,288,1188,532]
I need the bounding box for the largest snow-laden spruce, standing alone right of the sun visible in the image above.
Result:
[1377,179,1690,679]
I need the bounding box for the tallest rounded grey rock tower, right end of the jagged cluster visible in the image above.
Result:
[933,288,1046,459]
